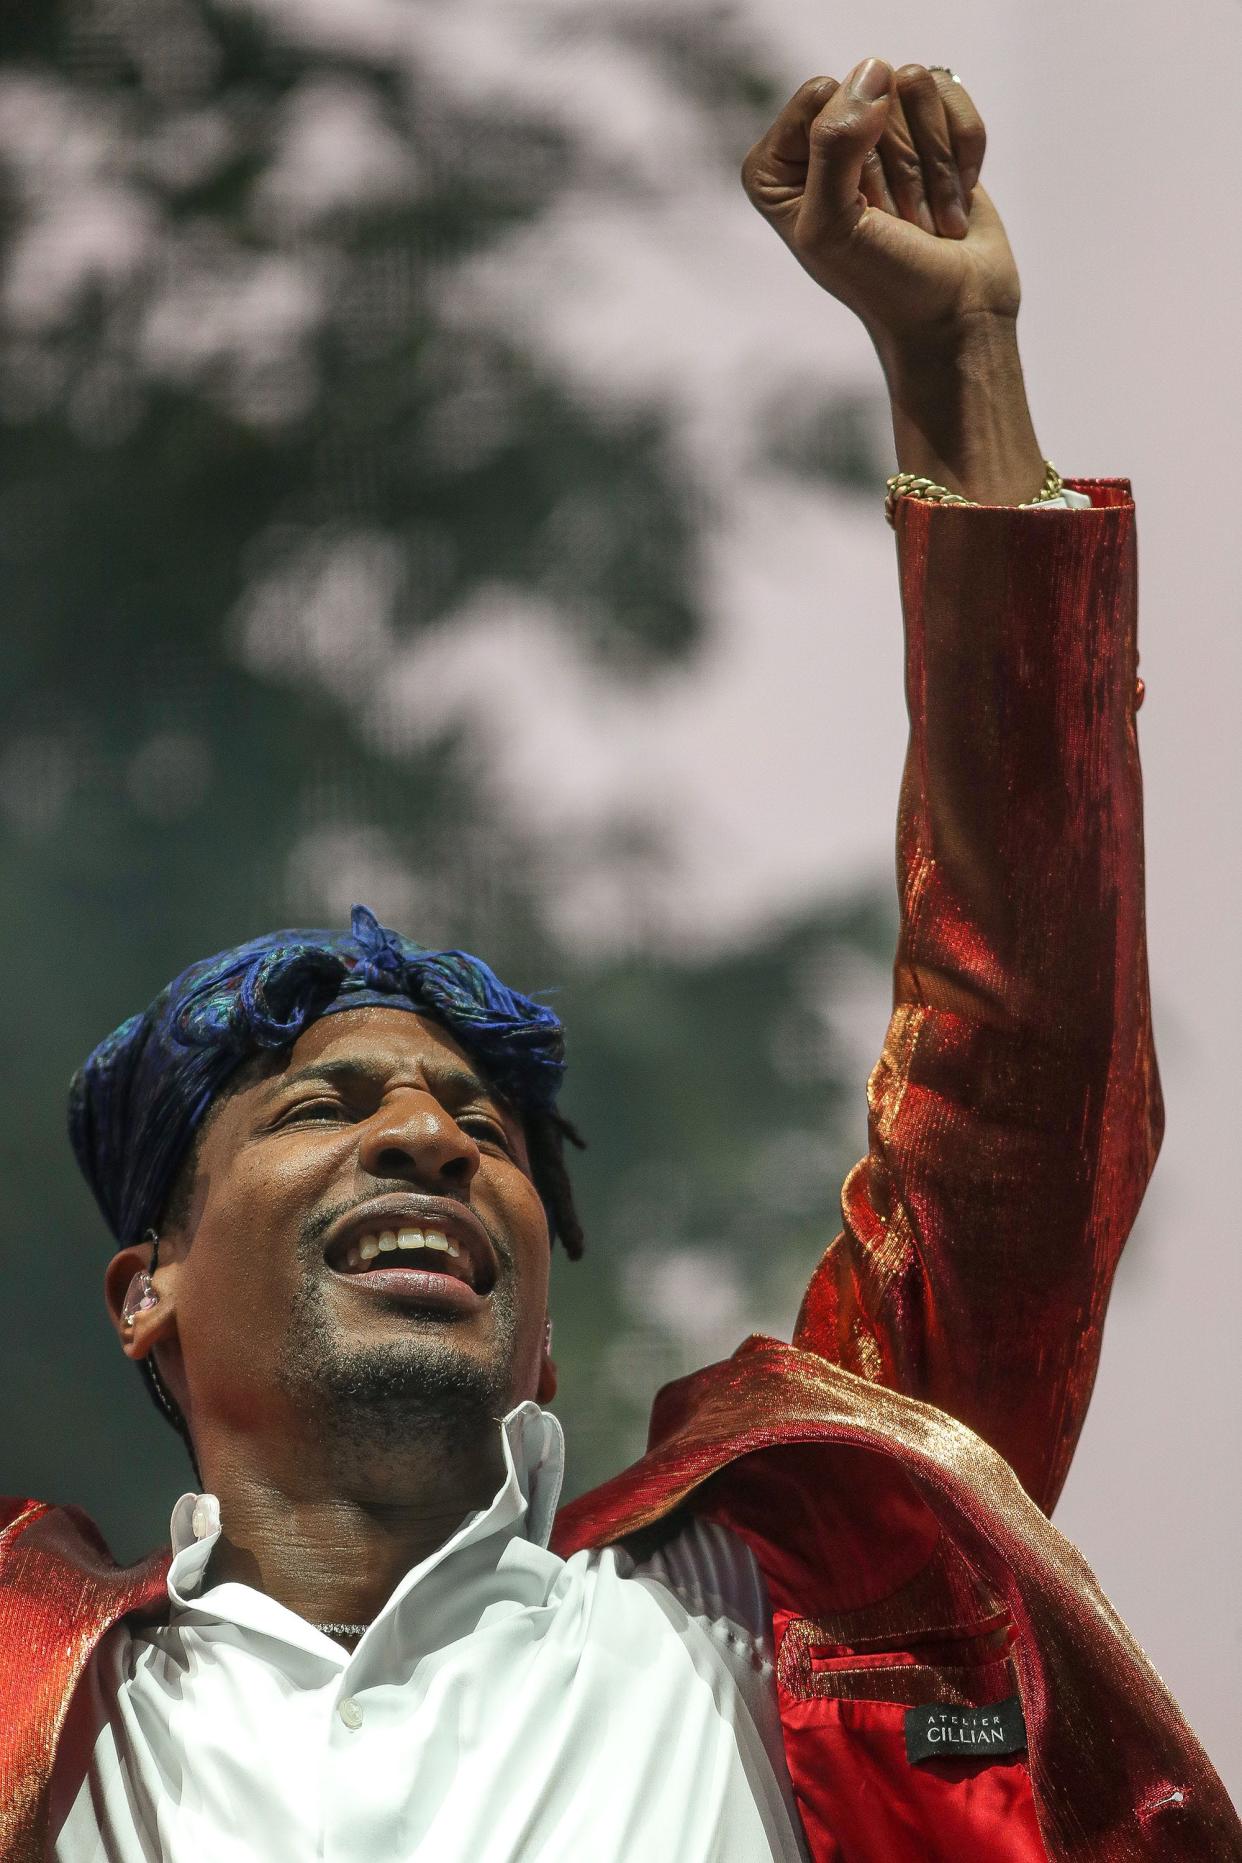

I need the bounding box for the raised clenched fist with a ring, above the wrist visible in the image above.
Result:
[741,58,1022,348]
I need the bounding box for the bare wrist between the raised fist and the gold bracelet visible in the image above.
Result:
[873,317,1045,505]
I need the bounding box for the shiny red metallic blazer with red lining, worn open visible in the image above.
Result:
[0,479,1242,1863]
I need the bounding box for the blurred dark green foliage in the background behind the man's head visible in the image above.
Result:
[0,0,894,1557]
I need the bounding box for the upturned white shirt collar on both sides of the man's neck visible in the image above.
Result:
[168,1401,564,1610]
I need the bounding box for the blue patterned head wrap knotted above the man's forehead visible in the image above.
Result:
[69,905,564,1243]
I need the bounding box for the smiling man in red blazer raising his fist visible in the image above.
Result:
[0,60,1242,1863]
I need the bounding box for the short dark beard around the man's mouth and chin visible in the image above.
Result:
[277,1258,518,1487]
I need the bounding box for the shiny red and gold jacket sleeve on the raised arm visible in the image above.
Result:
[793,479,1164,1511]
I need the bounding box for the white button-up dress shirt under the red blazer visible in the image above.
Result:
[52,1403,806,1863]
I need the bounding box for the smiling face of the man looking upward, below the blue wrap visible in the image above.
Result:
[115,1006,549,1468]
